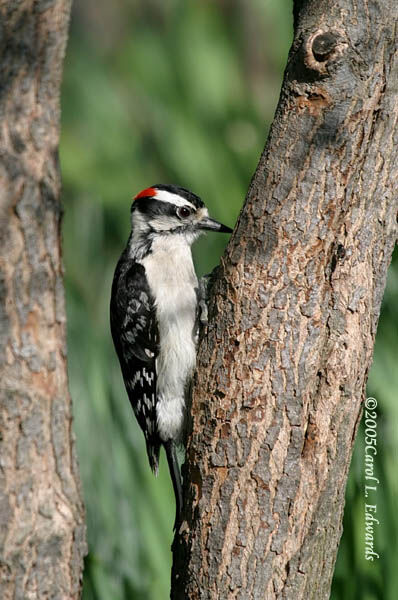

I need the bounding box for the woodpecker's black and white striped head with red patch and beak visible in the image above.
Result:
[131,184,232,251]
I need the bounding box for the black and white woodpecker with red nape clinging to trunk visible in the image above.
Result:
[110,185,232,528]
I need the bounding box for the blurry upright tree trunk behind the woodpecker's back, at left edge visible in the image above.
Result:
[0,0,86,600]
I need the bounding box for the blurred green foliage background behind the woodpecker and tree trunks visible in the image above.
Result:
[61,0,398,600]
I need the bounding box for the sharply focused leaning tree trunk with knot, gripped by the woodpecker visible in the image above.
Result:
[171,0,398,600]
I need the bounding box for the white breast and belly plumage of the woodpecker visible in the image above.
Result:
[140,235,198,441]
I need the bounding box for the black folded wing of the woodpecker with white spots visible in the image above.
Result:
[111,256,160,473]
